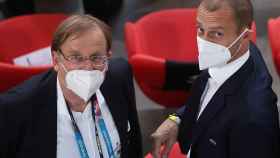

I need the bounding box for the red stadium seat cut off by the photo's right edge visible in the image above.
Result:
[268,17,280,75]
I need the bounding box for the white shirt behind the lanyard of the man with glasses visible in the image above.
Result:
[57,80,120,158]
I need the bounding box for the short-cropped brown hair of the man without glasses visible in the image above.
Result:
[201,0,254,31]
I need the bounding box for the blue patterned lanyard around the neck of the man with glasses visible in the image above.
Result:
[67,95,115,158]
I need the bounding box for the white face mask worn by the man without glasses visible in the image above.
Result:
[197,29,248,70]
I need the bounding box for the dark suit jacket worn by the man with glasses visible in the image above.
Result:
[0,59,142,158]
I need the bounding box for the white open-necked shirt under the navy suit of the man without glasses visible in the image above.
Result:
[188,50,250,157]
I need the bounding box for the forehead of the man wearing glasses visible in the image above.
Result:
[61,28,106,55]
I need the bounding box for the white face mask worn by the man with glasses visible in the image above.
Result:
[61,64,107,102]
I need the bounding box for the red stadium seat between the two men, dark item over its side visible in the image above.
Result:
[125,9,256,107]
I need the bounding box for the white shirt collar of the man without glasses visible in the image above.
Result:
[208,50,250,84]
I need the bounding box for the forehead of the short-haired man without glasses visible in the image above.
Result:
[197,4,236,29]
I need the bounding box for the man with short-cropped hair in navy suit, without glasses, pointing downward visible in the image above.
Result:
[152,0,280,158]
